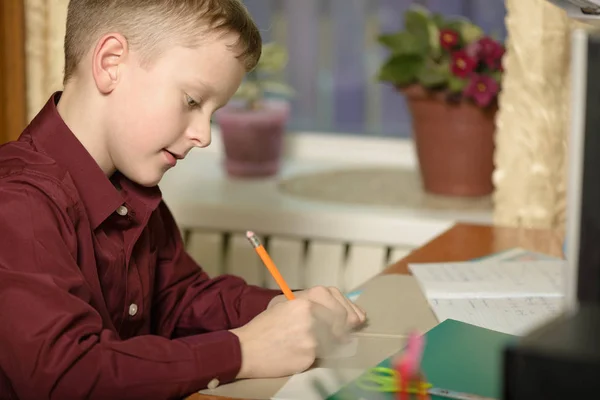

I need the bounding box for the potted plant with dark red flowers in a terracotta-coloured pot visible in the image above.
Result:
[378,6,505,196]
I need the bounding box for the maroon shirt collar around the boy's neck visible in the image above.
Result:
[30,92,161,229]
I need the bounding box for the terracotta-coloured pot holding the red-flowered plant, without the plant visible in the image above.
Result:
[399,85,498,197]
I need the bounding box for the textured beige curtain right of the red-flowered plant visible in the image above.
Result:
[494,0,573,229]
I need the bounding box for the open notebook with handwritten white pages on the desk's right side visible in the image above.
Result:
[409,249,566,335]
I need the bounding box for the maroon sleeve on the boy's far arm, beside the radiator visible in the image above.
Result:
[153,202,281,337]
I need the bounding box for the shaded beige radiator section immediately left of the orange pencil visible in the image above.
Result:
[225,234,265,286]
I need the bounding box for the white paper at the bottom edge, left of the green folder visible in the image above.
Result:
[271,368,364,400]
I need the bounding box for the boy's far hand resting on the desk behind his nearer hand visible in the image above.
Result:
[267,286,367,337]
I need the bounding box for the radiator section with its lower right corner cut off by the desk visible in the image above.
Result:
[344,245,387,290]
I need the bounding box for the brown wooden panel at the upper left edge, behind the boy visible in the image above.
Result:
[0,0,26,143]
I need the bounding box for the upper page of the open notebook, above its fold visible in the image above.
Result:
[409,260,566,299]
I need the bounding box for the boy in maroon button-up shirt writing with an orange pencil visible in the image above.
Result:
[0,0,365,400]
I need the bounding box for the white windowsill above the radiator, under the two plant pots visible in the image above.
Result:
[160,129,491,247]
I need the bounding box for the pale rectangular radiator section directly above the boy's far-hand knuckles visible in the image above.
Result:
[305,240,345,290]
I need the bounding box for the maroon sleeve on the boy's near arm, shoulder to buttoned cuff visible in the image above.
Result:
[0,178,241,400]
